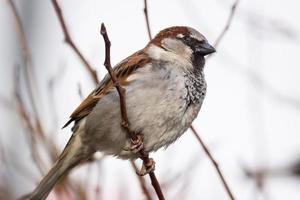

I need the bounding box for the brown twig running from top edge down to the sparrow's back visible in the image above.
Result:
[51,0,99,84]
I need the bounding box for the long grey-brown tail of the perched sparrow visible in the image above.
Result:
[29,135,87,200]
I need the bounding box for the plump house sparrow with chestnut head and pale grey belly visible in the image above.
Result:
[30,26,215,200]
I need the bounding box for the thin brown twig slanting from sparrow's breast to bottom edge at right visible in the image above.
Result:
[190,125,235,200]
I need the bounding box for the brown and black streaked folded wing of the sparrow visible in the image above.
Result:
[63,50,151,128]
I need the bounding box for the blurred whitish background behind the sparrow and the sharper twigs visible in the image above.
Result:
[0,0,300,200]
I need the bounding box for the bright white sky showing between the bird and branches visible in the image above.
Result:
[0,0,300,200]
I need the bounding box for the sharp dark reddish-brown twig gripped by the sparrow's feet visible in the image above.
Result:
[101,23,165,200]
